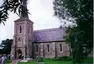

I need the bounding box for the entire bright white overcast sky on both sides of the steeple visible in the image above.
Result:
[0,0,73,43]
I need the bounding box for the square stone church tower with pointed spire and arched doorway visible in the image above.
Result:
[11,0,33,58]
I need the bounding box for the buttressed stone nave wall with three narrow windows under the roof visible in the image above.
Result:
[33,42,70,58]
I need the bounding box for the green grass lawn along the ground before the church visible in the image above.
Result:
[6,58,93,64]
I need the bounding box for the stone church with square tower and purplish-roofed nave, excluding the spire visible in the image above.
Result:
[11,19,70,58]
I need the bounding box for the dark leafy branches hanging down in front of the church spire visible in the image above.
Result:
[0,0,29,23]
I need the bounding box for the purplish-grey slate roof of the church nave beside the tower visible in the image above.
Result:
[34,28,66,42]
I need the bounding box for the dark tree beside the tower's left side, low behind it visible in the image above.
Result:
[0,39,13,54]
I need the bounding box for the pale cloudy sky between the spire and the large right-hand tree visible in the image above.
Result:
[28,0,59,29]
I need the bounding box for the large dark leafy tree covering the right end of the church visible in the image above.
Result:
[53,0,93,64]
